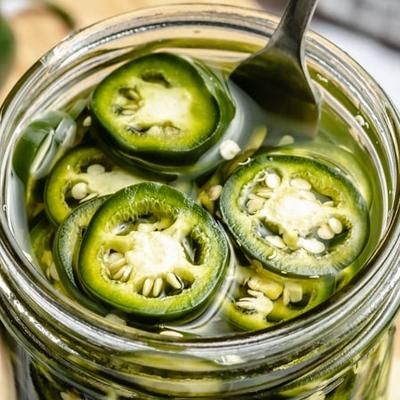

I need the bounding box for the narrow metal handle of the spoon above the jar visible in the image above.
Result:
[268,0,318,54]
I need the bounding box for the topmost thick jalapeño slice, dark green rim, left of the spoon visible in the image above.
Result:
[90,53,234,167]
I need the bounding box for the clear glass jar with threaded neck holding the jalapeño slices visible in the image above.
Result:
[0,5,400,400]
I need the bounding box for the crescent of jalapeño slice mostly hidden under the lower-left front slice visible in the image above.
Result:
[53,196,110,315]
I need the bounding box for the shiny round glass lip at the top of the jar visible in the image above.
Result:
[0,4,400,372]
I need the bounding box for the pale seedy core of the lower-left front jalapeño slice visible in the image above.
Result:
[102,217,203,297]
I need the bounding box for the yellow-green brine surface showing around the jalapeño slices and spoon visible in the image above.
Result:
[10,40,382,338]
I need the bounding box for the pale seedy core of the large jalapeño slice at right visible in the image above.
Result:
[243,170,351,254]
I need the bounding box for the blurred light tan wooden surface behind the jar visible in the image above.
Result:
[0,0,400,400]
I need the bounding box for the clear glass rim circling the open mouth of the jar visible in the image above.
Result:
[0,4,400,357]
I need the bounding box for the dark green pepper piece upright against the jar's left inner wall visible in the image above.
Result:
[12,111,76,219]
